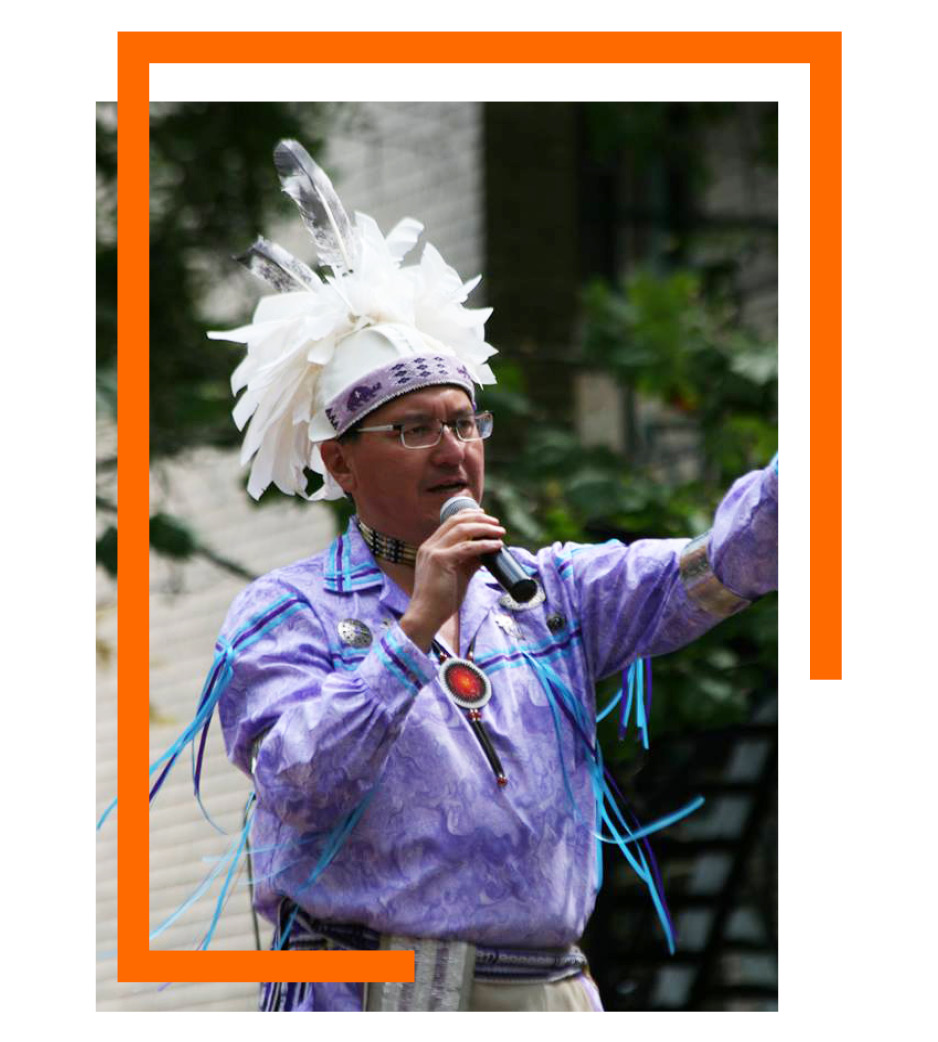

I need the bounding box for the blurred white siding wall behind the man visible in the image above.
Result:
[97,102,484,1010]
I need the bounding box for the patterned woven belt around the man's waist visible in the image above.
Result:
[263,900,587,1011]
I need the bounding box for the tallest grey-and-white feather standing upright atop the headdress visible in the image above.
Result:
[274,141,360,275]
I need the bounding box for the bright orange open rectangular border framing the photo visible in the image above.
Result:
[118,26,842,982]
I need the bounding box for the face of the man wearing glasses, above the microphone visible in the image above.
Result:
[324,387,485,545]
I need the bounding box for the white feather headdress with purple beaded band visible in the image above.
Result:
[208,141,496,499]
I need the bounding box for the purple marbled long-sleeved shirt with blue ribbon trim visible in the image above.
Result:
[219,463,777,997]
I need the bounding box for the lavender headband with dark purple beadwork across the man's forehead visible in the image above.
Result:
[325,354,475,435]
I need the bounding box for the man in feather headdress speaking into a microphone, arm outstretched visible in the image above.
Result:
[193,142,777,1011]
